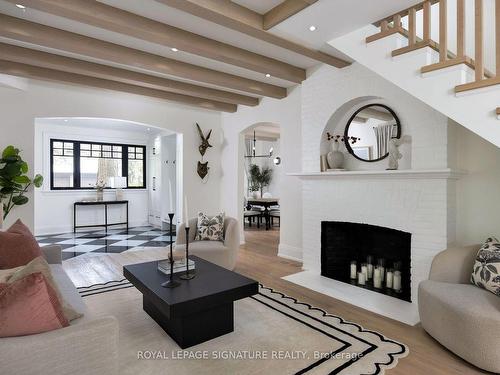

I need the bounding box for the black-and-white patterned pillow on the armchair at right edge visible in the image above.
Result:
[471,237,500,296]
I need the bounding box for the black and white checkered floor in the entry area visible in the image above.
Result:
[36,226,175,260]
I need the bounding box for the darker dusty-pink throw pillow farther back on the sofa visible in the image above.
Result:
[0,220,42,269]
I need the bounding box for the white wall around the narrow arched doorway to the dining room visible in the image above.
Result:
[221,87,302,259]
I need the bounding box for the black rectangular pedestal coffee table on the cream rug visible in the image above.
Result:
[123,256,259,349]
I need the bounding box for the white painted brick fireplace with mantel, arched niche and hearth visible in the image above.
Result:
[285,64,461,324]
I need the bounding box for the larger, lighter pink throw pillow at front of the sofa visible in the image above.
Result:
[0,272,69,337]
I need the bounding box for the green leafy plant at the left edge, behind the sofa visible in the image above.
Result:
[0,146,43,219]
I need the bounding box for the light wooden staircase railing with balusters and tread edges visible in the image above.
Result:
[366,0,500,101]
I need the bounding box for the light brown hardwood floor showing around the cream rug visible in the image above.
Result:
[64,228,487,375]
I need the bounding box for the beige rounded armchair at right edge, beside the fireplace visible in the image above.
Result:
[418,245,500,373]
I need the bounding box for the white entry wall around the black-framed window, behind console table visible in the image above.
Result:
[34,119,154,234]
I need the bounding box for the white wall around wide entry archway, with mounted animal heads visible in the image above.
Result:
[0,81,222,234]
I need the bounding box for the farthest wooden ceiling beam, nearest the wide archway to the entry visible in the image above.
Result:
[0,60,237,112]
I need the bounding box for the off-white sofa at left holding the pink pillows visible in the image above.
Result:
[0,246,118,375]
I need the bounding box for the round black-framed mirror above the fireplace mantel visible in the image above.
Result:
[344,104,401,162]
